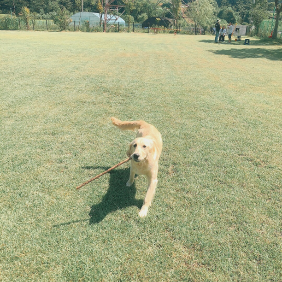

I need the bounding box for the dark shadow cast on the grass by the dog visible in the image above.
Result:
[83,167,143,224]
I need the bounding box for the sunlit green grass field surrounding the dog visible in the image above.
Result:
[0,31,282,282]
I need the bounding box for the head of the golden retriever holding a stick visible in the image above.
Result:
[126,137,154,162]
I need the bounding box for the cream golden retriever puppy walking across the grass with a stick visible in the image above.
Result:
[111,117,163,217]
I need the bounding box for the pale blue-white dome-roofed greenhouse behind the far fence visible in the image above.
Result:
[70,12,125,27]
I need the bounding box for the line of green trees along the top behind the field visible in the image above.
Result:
[0,0,282,38]
